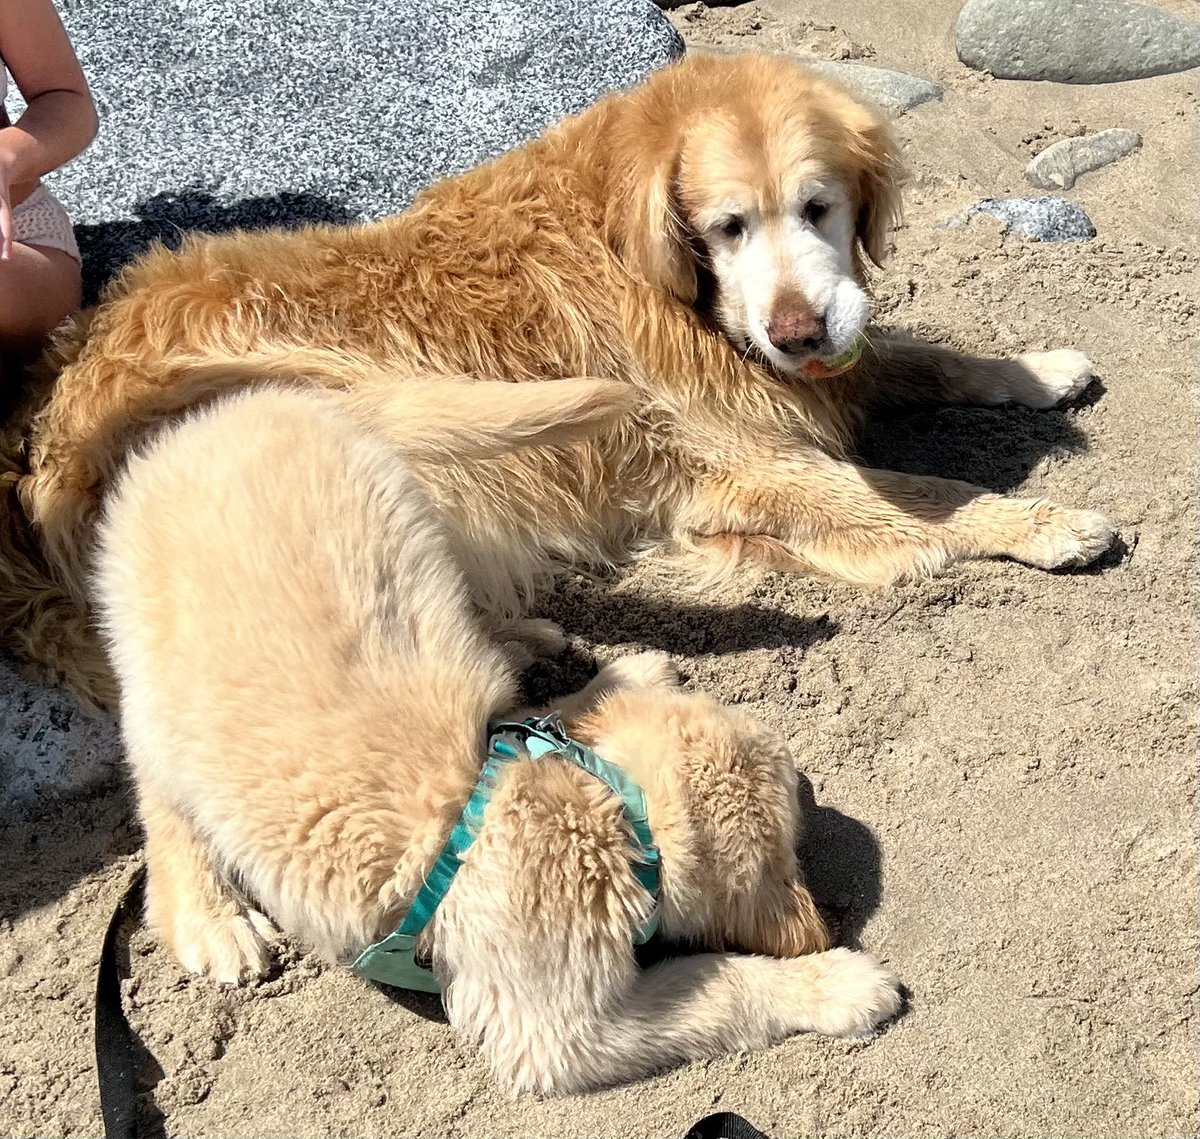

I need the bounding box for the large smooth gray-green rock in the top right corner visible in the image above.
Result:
[954,0,1200,83]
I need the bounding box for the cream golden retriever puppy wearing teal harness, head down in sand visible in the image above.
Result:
[95,382,900,1092]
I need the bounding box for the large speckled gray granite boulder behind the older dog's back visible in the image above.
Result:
[32,0,683,302]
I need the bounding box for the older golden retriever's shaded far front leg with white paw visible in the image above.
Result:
[859,336,1092,409]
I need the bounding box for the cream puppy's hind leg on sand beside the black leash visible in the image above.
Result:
[139,787,275,984]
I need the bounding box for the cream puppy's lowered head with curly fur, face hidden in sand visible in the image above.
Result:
[576,687,829,957]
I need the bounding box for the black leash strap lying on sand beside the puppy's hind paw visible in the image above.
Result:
[95,867,146,1139]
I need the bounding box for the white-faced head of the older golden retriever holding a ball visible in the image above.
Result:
[607,55,901,376]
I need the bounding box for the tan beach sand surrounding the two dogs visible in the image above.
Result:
[0,0,1198,1139]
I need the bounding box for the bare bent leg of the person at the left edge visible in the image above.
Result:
[0,241,83,355]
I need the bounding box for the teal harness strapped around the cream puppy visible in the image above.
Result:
[353,713,659,993]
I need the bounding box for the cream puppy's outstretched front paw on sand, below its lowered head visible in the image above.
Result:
[797,949,904,1037]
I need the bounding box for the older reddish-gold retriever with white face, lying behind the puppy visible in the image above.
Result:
[0,55,1112,703]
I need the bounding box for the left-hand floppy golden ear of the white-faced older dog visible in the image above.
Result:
[605,126,697,305]
